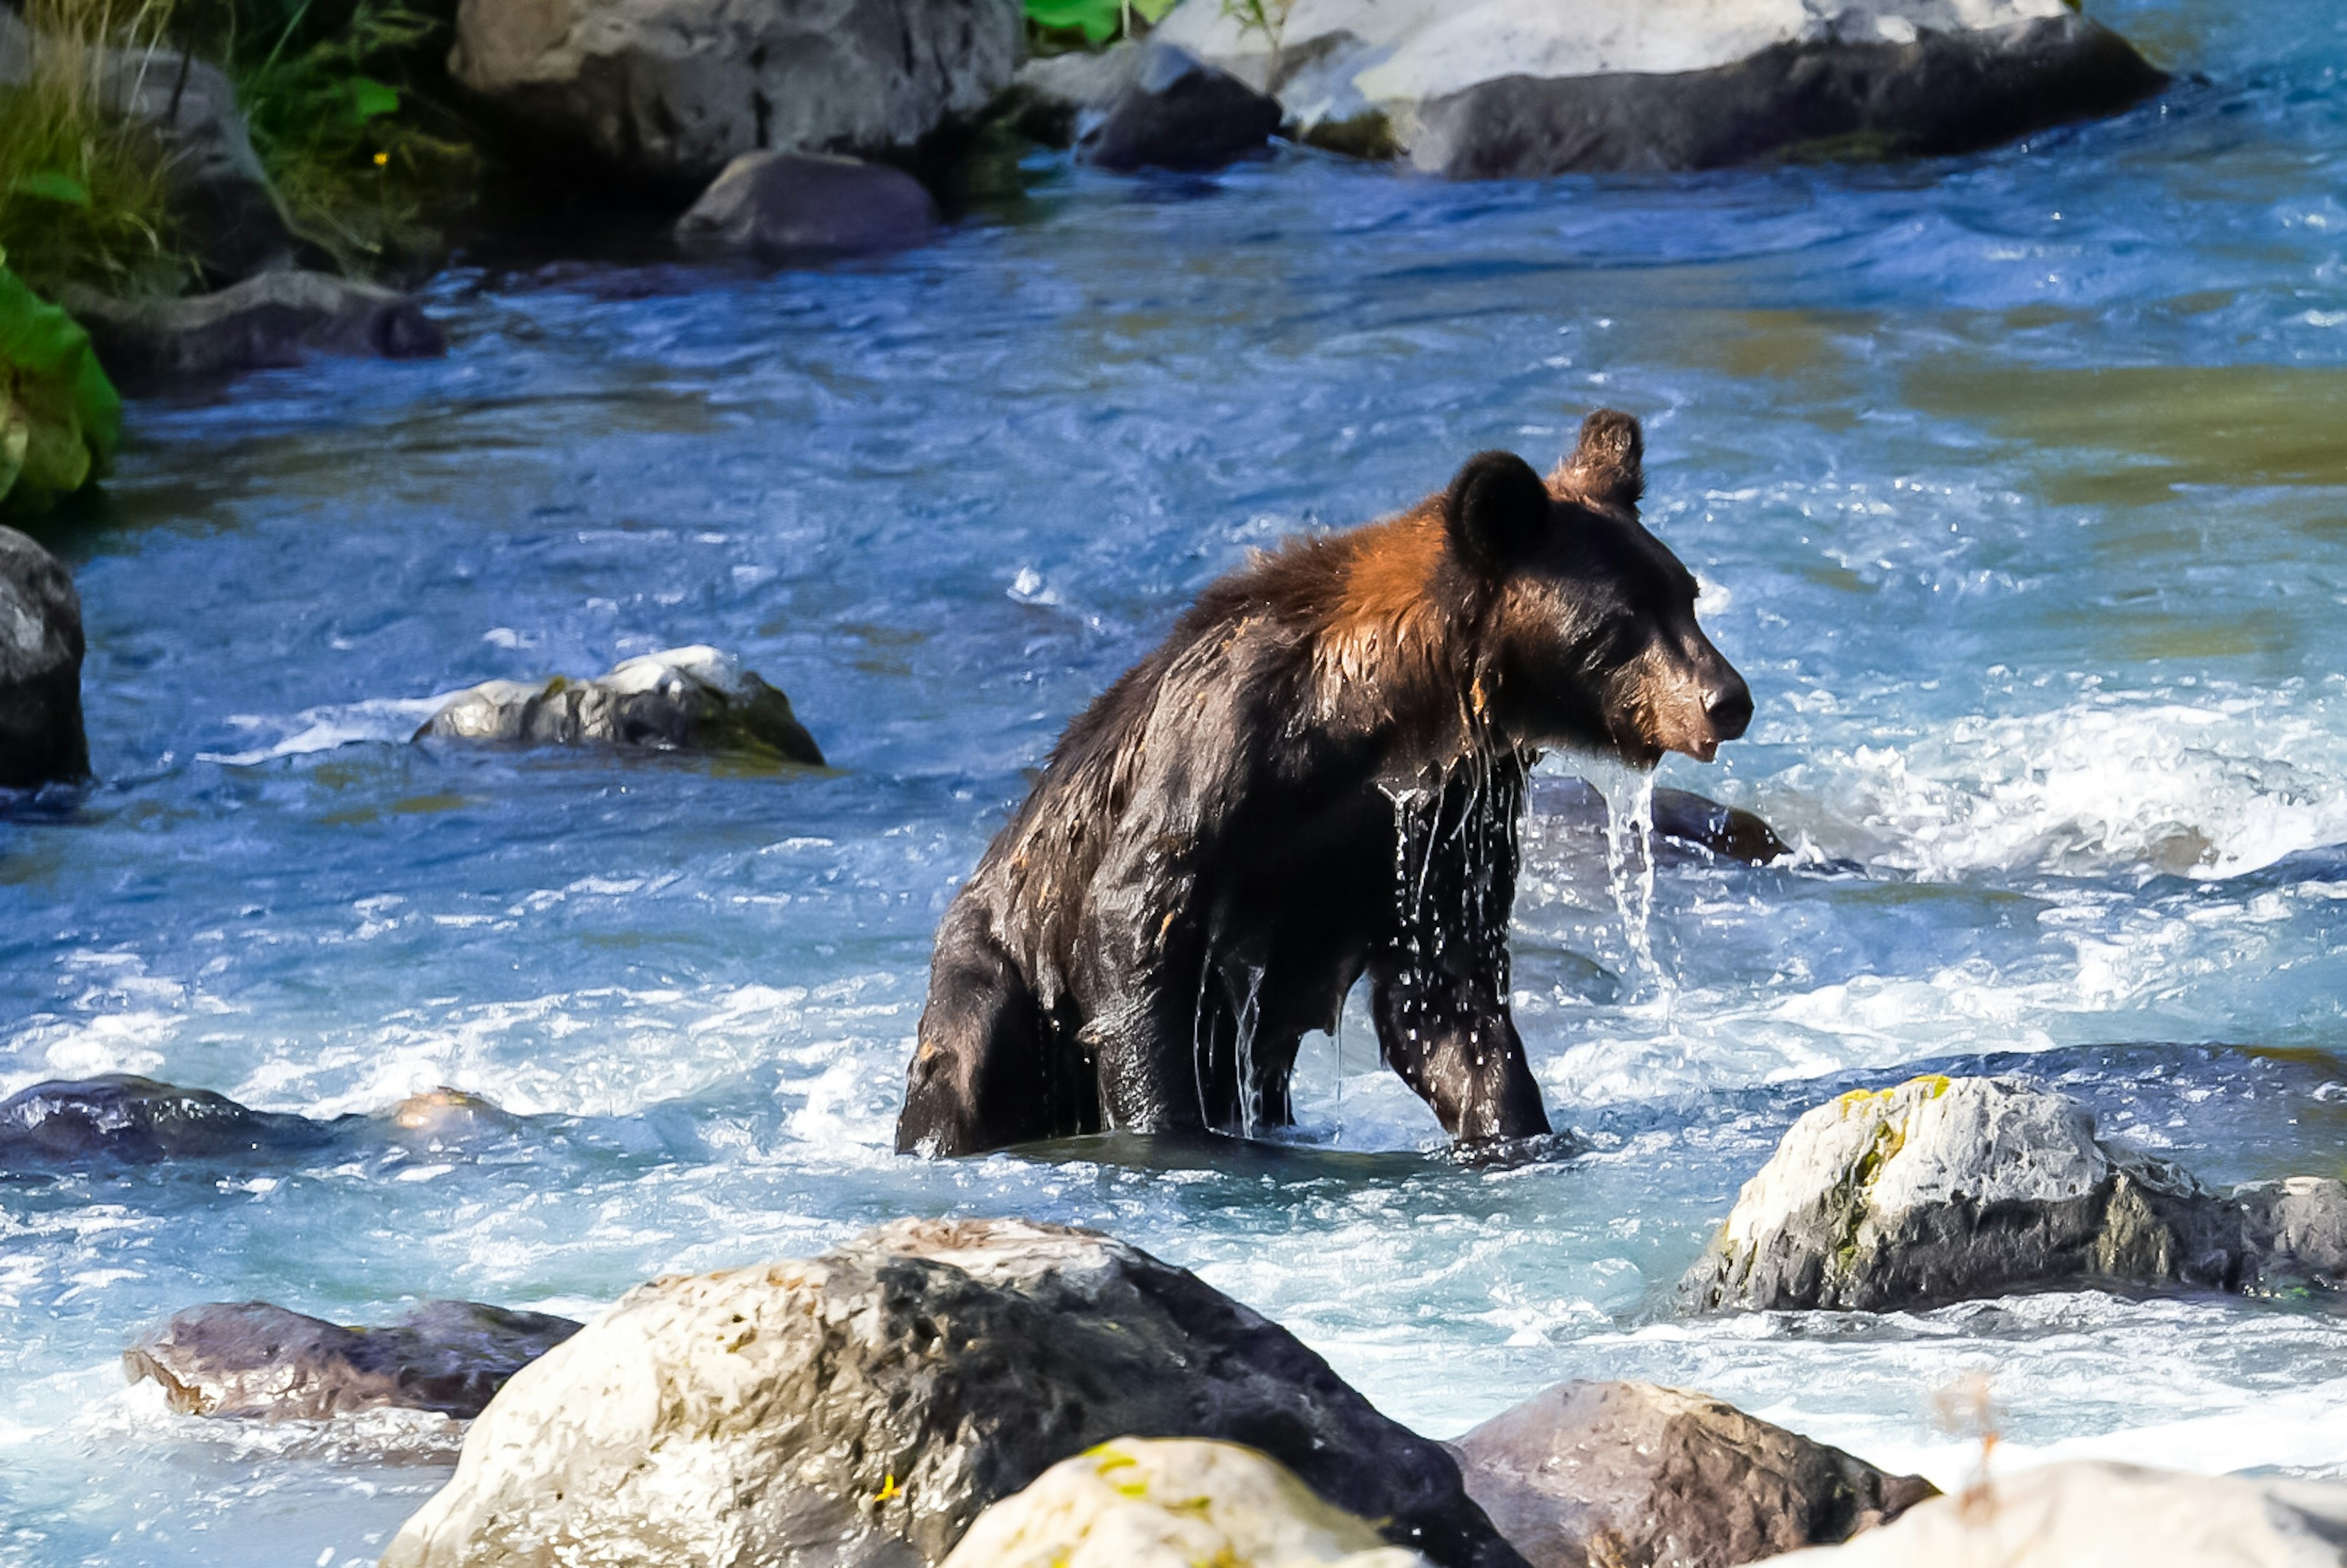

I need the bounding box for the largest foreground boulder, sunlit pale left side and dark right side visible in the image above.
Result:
[383,1220,1523,1568]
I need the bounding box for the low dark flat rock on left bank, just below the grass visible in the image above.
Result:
[64,270,448,376]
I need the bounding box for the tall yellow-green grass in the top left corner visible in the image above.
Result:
[0,0,193,293]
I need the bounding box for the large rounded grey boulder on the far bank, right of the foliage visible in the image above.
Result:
[448,0,1023,183]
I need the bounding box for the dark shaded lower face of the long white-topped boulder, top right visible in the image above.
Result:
[1411,14,2166,178]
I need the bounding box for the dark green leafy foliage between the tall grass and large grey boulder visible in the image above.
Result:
[232,0,479,273]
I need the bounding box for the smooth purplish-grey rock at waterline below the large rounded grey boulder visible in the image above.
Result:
[676,153,936,260]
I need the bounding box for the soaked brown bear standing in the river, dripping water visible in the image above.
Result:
[897,411,1753,1155]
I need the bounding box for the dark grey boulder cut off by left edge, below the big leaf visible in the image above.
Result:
[0,528,89,788]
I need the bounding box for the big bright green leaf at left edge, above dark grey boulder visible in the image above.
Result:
[0,265,122,510]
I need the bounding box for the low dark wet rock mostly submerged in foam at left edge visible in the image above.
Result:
[0,1072,333,1171]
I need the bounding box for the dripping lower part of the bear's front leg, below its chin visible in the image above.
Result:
[1371,953,1549,1143]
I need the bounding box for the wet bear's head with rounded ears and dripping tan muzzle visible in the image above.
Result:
[1444,408,1753,768]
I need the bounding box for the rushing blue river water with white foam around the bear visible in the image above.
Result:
[0,0,2347,1566]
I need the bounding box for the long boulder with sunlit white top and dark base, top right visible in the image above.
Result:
[1155,0,2166,178]
